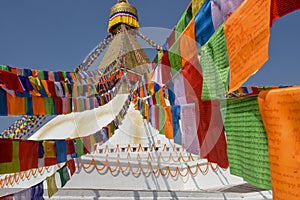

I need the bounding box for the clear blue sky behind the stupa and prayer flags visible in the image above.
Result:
[0,0,300,129]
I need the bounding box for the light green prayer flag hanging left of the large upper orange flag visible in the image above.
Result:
[198,25,229,100]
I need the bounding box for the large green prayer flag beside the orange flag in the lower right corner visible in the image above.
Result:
[222,96,272,189]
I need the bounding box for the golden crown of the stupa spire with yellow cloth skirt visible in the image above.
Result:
[108,0,139,32]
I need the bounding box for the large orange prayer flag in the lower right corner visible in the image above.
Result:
[259,86,300,200]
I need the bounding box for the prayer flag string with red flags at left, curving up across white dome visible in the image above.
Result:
[0,95,131,174]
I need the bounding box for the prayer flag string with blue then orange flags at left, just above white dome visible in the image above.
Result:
[0,74,123,116]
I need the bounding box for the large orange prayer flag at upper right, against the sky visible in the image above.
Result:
[224,0,271,92]
